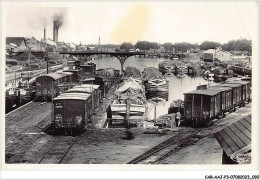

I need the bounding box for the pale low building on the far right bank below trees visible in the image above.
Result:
[202,49,232,62]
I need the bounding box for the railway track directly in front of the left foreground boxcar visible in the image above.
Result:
[37,136,78,164]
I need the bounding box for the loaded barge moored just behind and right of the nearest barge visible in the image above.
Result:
[143,67,169,101]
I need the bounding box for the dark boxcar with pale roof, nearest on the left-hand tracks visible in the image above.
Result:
[51,93,92,135]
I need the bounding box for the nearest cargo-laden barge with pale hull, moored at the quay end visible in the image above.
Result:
[107,68,147,126]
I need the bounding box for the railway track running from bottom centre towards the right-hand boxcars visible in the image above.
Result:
[127,129,201,164]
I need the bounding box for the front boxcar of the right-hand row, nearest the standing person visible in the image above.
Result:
[184,89,222,126]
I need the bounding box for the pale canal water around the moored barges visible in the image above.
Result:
[94,56,212,119]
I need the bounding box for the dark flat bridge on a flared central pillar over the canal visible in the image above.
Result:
[59,51,145,72]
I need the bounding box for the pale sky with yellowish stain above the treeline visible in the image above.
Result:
[3,2,257,44]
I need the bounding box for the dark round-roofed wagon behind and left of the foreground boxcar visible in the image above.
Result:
[35,72,72,101]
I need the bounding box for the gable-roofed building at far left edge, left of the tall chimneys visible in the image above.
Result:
[5,37,27,51]
